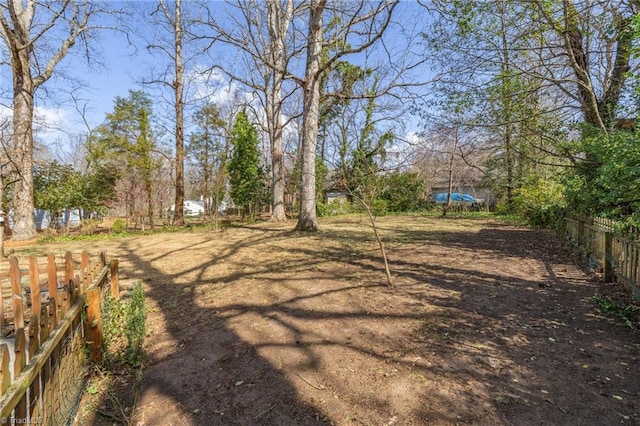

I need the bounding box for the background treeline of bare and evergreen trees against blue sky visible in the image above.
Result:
[0,0,640,240]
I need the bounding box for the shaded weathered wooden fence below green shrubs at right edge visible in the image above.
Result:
[566,216,640,300]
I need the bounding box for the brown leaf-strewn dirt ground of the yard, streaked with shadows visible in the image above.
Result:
[18,216,640,426]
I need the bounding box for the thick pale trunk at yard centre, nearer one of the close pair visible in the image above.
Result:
[295,0,326,231]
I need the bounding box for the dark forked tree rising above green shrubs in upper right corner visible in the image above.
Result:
[525,0,640,131]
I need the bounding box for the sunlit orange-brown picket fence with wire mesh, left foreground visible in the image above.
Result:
[0,252,118,425]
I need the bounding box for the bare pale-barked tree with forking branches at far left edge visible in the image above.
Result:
[0,0,97,240]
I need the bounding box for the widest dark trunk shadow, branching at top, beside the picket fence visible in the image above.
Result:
[113,230,332,425]
